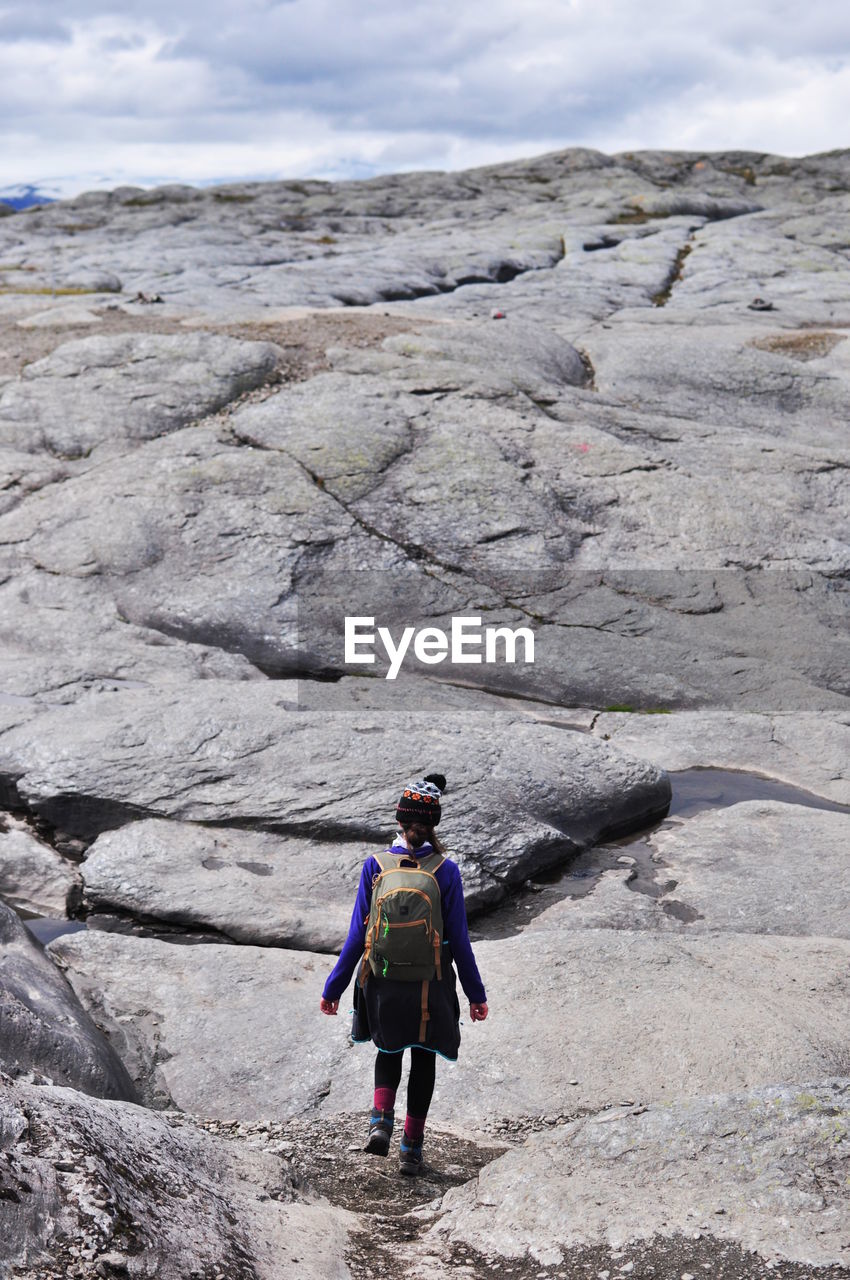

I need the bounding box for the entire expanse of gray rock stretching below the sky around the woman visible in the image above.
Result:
[0,150,850,1280]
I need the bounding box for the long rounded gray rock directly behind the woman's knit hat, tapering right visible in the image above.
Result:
[0,681,670,896]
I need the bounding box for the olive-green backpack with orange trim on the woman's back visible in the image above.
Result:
[360,850,445,1039]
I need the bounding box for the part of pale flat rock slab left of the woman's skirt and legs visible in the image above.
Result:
[49,929,373,1120]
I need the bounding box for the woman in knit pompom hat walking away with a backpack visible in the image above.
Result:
[321,773,488,1174]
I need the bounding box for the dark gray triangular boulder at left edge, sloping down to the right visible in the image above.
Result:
[0,901,136,1101]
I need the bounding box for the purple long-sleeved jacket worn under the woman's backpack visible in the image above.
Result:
[321,844,486,1005]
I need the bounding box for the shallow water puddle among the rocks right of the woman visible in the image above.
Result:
[470,768,850,941]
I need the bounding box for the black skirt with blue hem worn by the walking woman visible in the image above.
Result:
[351,948,461,1062]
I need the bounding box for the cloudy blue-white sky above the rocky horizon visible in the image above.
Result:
[0,0,850,193]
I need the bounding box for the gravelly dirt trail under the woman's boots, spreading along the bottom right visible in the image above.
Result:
[174,1111,846,1280]
